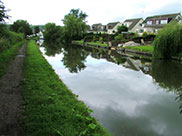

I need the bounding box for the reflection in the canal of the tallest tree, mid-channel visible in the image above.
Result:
[62,45,88,73]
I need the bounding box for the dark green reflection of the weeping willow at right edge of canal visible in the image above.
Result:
[152,60,182,113]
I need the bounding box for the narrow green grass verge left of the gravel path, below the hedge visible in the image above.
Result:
[0,41,25,78]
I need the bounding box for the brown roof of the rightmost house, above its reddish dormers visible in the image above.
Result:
[144,13,180,23]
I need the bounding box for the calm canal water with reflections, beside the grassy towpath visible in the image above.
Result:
[40,45,182,136]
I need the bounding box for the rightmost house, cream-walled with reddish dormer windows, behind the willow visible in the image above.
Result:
[143,13,182,33]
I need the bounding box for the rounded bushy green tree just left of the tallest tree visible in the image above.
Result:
[43,23,64,48]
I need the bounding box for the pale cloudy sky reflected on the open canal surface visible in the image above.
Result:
[41,48,182,136]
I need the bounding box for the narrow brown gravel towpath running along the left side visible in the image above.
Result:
[0,45,26,136]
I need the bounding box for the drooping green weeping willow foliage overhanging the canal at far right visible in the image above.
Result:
[153,22,182,59]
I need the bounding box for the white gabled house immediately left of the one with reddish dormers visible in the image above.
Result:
[124,18,144,33]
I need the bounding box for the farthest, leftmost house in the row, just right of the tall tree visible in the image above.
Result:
[89,23,107,33]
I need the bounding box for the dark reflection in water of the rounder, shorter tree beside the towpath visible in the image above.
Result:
[43,43,62,56]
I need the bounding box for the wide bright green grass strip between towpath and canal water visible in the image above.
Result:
[23,41,109,136]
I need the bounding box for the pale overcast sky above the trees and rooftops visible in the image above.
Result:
[2,0,182,25]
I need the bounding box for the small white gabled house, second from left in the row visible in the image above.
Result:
[106,22,122,34]
